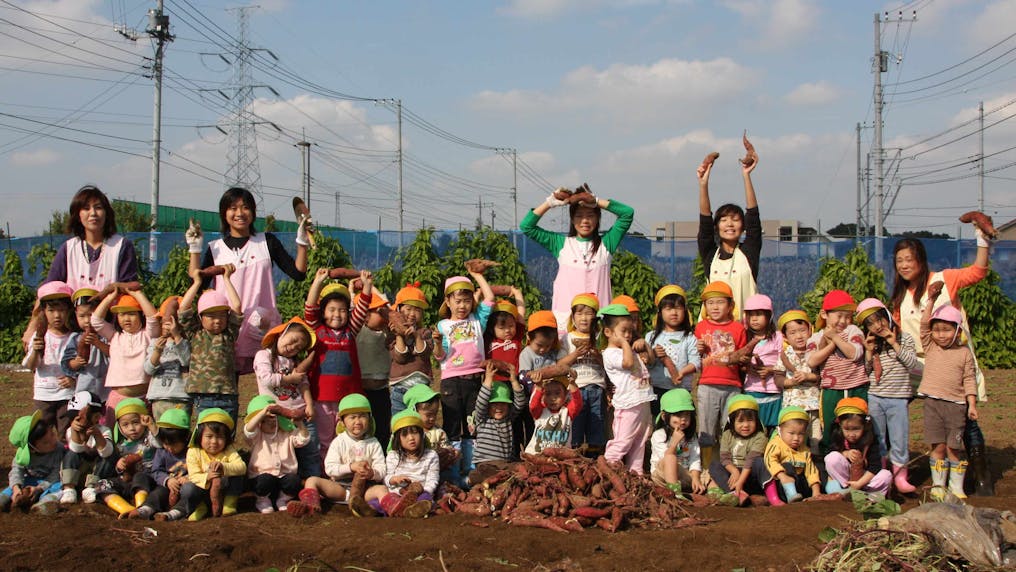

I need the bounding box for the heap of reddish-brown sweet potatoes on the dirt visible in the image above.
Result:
[437,449,710,532]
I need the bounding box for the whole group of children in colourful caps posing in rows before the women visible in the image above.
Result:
[0,260,977,520]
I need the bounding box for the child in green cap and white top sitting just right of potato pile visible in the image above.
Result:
[639,387,706,495]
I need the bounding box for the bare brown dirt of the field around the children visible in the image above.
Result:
[0,370,1016,571]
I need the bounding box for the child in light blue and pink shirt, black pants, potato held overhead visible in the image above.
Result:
[434,271,494,474]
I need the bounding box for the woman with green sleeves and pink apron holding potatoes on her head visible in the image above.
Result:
[519,187,635,329]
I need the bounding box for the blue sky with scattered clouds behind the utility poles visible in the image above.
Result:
[0,0,1016,236]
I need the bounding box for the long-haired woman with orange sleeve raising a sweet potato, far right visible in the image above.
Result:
[890,227,995,496]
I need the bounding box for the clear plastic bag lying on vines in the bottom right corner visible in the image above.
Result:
[879,503,1016,567]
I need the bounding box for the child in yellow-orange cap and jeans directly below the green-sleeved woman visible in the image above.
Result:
[560,294,607,457]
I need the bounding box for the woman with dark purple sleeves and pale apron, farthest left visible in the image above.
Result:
[22,185,137,347]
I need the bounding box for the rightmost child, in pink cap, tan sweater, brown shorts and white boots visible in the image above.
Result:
[917,281,977,500]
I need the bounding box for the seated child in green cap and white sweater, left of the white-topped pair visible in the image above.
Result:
[289,393,387,516]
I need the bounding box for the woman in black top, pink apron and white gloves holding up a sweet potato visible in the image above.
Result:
[186,187,308,374]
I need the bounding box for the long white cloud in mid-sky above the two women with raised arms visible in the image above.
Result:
[472,58,756,123]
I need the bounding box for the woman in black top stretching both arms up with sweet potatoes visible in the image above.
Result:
[697,150,762,320]
